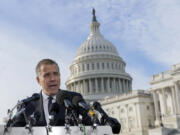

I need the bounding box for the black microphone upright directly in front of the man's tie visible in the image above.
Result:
[49,102,59,126]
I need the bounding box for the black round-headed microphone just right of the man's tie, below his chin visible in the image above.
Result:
[56,91,73,109]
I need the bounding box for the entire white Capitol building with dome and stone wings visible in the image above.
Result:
[66,9,180,135]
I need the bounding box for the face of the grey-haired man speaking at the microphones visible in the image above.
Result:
[36,64,60,96]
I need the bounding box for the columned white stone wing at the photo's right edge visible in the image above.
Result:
[149,64,180,128]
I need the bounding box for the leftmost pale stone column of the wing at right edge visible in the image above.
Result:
[153,91,161,126]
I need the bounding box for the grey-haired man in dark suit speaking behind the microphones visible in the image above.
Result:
[13,59,91,126]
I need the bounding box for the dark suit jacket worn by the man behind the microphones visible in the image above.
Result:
[12,90,91,127]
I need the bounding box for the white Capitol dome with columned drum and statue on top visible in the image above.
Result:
[66,9,132,101]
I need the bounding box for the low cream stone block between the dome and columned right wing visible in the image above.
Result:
[100,90,155,135]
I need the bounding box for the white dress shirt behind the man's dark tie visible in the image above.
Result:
[42,91,56,124]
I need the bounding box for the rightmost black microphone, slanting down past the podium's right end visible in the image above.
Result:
[93,102,121,134]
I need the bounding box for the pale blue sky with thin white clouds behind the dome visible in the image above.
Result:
[0,0,180,123]
